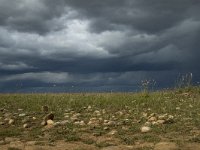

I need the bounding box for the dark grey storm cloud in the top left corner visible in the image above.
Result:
[0,0,72,34]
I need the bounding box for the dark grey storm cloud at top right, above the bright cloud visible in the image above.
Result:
[67,0,200,33]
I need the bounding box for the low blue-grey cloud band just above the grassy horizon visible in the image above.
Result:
[0,71,200,92]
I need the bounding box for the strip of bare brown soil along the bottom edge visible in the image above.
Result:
[0,138,200,150]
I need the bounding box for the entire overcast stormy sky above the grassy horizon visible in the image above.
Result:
[0,0,200,92]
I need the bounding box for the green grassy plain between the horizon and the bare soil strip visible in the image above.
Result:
[0,87,200,148]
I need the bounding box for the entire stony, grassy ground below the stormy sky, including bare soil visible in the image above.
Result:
[0,88,200,150]
